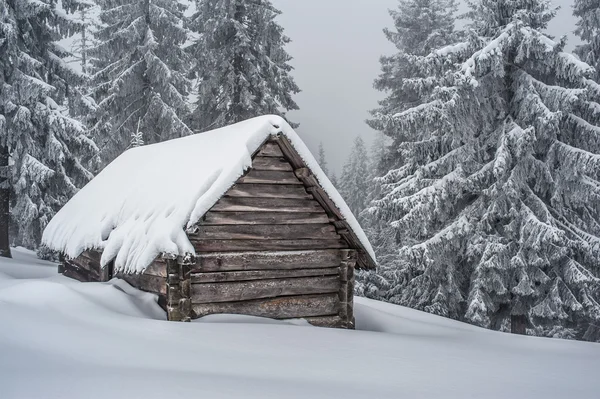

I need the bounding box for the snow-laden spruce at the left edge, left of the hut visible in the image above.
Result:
[0,0,96,256]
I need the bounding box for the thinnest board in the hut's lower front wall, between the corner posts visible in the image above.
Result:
[191,267,340,283]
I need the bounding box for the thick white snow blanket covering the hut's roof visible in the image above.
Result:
[42,116,375,273]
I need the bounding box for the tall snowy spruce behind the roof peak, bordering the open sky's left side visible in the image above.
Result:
[190,0,300,131]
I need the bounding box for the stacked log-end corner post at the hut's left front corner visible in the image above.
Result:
[164,256,193,321]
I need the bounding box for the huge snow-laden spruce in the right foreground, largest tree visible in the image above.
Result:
[374,0,600,338]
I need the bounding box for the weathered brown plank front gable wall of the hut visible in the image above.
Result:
[185,142,356,327]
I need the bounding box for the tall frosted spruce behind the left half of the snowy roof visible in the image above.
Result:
[90,0,192,163]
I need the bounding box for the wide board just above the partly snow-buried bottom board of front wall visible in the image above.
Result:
[192,294,339,319]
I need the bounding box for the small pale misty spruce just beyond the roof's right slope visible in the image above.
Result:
[339,136,370,220]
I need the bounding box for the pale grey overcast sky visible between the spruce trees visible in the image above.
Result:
[272,0,575,173]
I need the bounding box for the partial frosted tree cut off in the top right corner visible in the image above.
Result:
[573,0,600,82]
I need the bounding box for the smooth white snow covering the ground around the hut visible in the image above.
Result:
[0,250,600,399]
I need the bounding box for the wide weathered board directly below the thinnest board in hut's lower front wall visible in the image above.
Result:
[191,276,341,303]
